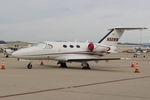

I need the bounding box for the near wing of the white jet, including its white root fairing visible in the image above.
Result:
[56,54,129,62]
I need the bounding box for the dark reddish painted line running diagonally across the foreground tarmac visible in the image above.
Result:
[0,76,150,99]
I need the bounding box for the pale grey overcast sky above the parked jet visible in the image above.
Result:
[0,0,150,43]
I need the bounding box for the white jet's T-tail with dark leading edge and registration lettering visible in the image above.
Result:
[98,28,147,46]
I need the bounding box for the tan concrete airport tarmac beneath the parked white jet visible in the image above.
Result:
[0,53,150,100]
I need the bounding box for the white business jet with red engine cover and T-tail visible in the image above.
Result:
[12,28,146,69]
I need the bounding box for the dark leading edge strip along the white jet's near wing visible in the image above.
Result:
[67,58,130,62]
